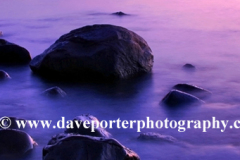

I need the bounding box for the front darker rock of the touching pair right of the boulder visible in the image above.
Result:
[162,90,204,106]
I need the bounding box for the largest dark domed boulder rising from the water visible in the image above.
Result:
[30,25,153,79]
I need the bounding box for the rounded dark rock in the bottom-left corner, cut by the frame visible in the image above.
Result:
[0,129,37,157]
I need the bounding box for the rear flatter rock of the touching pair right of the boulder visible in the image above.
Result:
[173,84,212,99]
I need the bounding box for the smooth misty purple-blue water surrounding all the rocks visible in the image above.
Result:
[0,0,240,160]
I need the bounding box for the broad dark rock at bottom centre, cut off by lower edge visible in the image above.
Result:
[43,134,140,160]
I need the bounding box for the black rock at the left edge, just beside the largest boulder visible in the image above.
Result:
[0,39,31,65]
